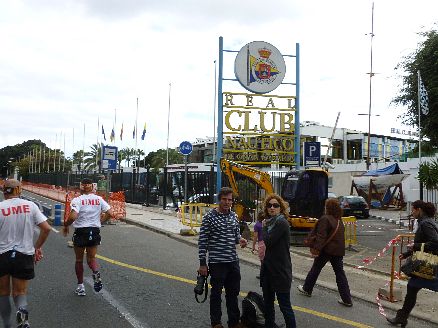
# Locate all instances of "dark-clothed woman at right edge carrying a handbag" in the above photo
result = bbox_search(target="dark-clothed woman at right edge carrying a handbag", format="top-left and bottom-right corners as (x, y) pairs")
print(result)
(386, 200), (438, 327)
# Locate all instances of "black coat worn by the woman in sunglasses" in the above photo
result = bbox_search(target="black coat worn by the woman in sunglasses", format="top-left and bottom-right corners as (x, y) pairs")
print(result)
(260, 216), (292, 293)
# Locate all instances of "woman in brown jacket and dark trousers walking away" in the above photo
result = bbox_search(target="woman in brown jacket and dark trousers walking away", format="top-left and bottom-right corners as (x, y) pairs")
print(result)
(297, 198), (353, 307)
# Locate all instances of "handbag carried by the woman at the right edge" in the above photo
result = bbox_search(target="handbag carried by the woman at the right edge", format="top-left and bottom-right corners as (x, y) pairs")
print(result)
(400, 243), (438, 280)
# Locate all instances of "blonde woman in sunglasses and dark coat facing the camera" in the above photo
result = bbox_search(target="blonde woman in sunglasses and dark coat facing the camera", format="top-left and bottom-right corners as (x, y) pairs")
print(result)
(260, 194), (296, 328)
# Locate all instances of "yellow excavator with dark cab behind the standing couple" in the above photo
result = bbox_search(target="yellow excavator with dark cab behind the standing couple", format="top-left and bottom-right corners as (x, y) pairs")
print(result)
(220, 158), (328, 232)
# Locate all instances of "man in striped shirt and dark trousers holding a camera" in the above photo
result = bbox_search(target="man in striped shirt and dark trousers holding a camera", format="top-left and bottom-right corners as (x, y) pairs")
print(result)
(198, 187), (247, 328)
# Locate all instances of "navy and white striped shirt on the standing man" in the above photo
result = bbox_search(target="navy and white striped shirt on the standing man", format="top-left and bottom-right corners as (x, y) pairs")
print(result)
(198, 209), (240, 265)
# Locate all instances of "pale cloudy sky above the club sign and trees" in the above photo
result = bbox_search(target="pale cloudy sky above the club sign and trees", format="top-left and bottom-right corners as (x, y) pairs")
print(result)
(0, 0), (438, 155)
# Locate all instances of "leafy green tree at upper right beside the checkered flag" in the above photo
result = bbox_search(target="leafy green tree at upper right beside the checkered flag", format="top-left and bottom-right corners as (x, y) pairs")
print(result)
(392, 26), (438, 148)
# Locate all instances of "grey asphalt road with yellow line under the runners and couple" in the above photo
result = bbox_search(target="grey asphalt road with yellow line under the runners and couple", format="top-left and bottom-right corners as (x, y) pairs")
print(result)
(0, 191), (432, 328)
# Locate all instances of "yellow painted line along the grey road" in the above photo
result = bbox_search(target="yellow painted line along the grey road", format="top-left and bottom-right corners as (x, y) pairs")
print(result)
(96, 255), (372, 328)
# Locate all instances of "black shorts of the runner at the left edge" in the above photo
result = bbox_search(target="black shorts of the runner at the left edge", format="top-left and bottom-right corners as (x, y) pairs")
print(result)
(0, 251), (35, 280)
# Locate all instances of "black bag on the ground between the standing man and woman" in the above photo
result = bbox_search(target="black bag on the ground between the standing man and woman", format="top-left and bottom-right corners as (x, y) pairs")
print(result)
(240, 292), (265, 328)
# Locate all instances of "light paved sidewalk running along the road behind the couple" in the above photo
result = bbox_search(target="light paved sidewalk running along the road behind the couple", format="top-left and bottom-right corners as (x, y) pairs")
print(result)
(120, 203), (438, 324)
